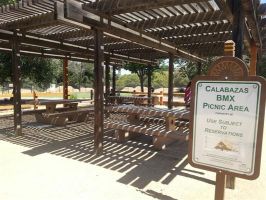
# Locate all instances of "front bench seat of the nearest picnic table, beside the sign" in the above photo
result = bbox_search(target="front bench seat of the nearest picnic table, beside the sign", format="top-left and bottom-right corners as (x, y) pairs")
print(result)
(104, 120), (189, 150)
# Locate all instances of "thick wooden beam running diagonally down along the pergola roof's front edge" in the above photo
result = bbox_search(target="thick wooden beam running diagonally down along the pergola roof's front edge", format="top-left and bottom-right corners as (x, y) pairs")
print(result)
(57, 1), (204, 61)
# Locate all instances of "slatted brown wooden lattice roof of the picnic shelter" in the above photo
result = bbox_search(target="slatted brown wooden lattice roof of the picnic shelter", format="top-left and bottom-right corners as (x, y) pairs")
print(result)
(0, 0), (266, 63)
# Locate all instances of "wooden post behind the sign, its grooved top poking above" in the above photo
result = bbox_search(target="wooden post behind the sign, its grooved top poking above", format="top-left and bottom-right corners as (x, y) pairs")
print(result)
(224, 40), (235, 189)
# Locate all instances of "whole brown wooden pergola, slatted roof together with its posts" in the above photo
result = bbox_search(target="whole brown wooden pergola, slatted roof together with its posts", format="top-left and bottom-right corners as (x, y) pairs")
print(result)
(0, 0), (265, 153)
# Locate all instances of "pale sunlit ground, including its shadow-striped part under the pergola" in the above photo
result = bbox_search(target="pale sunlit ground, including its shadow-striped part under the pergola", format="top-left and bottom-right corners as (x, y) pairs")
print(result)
(0, 111), (266, 200)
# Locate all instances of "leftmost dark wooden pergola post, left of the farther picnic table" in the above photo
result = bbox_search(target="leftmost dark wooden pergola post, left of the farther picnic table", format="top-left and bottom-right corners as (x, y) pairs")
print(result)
(11, 32), (23, 136)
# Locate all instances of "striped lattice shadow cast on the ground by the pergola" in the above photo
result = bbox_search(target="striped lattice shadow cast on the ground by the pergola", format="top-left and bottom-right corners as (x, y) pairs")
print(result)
(0, 113), (215, 200)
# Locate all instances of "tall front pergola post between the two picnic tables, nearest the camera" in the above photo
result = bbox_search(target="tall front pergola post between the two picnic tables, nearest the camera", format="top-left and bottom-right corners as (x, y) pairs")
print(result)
(94, 29), (104, 155)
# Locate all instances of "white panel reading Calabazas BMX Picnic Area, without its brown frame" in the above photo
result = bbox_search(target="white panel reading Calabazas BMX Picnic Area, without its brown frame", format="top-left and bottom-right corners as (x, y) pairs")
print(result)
(192, 80), (261, 175)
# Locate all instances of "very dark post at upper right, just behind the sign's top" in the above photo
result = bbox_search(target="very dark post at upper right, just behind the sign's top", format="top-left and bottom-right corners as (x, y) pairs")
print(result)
(228, 0), (245, 59)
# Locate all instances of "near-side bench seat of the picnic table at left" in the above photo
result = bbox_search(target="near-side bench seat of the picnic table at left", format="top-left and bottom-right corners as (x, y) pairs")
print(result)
(39, 108), (94, 126)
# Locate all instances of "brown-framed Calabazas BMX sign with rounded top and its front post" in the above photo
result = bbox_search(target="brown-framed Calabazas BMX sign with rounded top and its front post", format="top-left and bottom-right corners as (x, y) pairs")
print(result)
(189, 57), (265, 199)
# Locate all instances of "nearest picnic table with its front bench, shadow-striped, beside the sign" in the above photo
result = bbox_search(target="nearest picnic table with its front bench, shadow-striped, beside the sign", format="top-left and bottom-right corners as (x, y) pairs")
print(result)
(104, 105), (189, 150)
